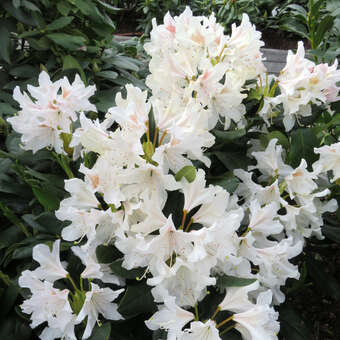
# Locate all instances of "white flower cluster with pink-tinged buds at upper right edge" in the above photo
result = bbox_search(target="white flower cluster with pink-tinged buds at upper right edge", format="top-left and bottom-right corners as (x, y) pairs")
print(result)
(260, 41), (340, 131)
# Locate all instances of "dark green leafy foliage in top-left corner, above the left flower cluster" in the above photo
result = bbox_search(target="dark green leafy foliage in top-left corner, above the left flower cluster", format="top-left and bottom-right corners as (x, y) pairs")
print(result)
(0, 0), (145, 116)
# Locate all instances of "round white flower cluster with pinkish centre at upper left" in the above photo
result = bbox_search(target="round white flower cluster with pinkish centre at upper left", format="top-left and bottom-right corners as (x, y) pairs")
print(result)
(8, 72), (97, 153)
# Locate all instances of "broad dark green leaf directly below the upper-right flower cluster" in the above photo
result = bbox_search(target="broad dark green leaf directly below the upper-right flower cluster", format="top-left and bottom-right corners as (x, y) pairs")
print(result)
(287, 128), (319, 169)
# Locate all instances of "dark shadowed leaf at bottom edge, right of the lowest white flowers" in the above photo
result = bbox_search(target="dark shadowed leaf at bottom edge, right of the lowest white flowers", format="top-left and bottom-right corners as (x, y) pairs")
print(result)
(279, 306), (312, 340)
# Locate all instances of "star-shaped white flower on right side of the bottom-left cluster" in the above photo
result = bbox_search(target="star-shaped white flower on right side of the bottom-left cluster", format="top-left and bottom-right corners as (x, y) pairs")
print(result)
(76, 283), (124, 339)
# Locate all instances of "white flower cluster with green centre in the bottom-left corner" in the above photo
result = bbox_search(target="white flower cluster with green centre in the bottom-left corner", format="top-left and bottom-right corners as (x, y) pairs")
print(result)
(19, 240), (123, 340)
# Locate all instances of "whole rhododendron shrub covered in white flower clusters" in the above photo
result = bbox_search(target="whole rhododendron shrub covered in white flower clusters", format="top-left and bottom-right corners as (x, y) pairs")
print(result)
(8, 8), (340, 340)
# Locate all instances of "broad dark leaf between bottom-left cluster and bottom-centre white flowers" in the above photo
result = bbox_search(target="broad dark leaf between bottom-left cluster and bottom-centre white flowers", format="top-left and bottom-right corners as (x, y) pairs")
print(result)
(118, 284), (157, 319)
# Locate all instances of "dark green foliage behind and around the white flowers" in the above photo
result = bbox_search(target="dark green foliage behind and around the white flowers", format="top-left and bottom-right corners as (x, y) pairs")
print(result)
(0, 0), (340, 340)
